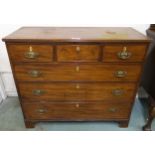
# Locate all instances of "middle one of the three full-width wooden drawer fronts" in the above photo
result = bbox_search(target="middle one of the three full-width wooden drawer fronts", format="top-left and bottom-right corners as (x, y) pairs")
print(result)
(19, 83), (136, 102)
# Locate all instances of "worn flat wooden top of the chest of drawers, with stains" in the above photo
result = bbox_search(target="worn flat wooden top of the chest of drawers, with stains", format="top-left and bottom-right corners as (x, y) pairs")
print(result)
(3, 27), (149, 42)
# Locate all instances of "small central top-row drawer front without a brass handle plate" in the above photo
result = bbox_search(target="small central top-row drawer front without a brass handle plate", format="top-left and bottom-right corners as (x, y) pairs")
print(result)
(57, 45), (101, 62)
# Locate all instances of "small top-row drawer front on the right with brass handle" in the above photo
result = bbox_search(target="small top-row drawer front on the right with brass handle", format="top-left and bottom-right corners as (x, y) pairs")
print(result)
(103, 44), (147, 62)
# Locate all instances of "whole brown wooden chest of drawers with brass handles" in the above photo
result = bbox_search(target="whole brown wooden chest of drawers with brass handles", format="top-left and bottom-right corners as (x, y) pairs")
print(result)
(3, 27), (149, 127)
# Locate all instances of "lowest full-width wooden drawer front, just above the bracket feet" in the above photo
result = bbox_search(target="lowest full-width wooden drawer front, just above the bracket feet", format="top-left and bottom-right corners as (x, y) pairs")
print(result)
(23, 102), (131, 121)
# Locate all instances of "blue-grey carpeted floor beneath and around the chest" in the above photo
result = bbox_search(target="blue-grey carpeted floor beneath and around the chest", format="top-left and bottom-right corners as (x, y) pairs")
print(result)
(0, 97), (155, 131)
